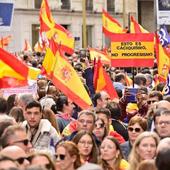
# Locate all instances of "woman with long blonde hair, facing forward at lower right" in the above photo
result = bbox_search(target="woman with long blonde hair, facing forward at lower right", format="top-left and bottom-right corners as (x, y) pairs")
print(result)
(128, 132), (159, 170)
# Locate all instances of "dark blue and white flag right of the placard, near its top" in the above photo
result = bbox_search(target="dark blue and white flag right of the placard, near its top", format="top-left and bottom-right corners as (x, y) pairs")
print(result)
(158, 25), (170, 47)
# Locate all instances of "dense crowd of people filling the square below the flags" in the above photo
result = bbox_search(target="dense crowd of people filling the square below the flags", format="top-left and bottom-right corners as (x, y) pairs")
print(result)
(0, 48), (170, 170)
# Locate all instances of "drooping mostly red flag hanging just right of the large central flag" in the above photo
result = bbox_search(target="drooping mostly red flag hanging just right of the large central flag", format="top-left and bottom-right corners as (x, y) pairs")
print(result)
(93, 59), (118, 99)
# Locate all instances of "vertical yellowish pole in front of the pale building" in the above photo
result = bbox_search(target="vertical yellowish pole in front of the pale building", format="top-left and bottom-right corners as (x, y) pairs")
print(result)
(82, 0), (87, 49)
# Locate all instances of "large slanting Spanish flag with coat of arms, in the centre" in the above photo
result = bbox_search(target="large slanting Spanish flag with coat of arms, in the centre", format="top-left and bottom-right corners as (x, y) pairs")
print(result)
(47, 51), (92, 109)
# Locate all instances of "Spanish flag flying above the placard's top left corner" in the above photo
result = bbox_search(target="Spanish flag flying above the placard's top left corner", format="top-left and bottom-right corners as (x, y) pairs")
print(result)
(102, 9), (125, 37)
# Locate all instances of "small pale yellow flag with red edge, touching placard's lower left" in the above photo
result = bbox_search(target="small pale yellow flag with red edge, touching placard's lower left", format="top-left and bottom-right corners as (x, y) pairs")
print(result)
(89, 48), (110, 64)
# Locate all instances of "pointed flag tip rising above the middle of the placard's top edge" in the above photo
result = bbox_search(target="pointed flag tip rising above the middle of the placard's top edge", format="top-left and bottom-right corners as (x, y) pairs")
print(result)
(130, 16), (149, 33)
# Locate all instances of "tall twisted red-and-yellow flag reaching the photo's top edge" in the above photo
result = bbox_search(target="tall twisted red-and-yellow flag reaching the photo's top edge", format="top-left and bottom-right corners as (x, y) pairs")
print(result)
(40, 0), (74, 54)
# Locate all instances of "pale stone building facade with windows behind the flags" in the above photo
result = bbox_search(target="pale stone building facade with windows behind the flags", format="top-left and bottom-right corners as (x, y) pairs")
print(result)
(0, 0), (142, 52)
